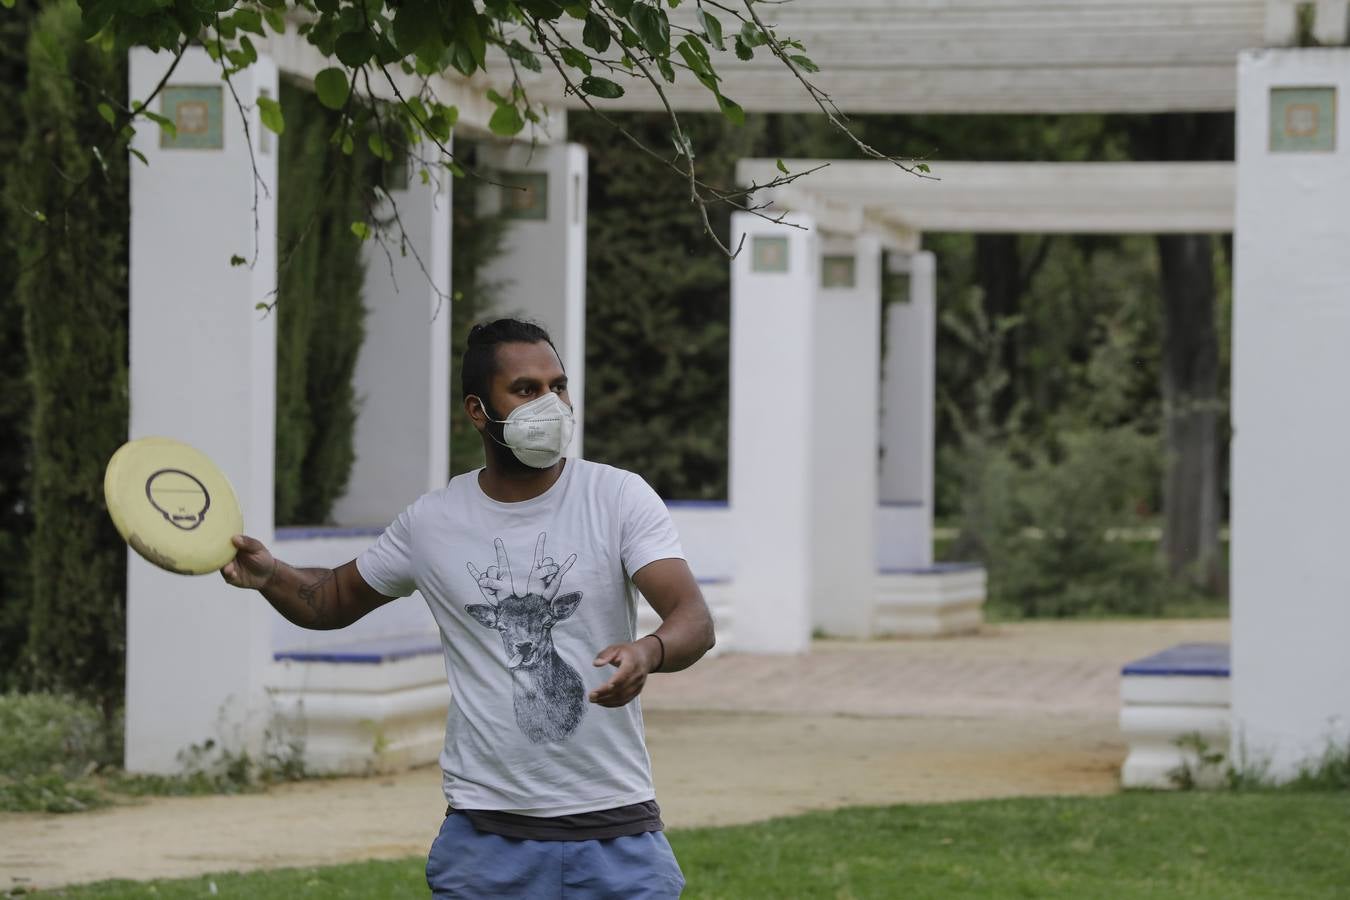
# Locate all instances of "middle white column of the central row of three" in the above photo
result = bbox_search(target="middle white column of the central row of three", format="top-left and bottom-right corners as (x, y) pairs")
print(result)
(801, 236), (882, 638)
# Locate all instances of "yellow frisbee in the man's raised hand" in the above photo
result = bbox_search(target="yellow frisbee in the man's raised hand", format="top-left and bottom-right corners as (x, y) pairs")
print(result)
(103, 437), (244, 575)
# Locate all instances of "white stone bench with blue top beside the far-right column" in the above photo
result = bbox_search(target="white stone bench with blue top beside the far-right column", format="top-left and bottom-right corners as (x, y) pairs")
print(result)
(1121, 644), (1230, 788)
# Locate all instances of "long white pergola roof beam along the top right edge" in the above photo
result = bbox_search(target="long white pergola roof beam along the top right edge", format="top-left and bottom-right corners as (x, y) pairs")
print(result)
(507, 0), (1345, 113)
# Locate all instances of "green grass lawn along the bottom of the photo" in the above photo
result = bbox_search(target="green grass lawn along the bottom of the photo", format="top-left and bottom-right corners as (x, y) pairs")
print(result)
(43, 791), (1350, 900)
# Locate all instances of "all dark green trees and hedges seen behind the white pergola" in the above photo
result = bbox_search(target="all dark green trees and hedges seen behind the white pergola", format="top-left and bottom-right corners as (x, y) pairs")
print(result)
(0, 0), (1233, 806)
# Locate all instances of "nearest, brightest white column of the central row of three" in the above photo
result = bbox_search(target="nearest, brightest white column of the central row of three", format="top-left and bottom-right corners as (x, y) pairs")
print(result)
(729, 213), (825, 653)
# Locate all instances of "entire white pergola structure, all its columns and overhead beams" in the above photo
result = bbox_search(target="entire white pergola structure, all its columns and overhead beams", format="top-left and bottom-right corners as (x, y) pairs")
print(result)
(127, 0), (1350, 772)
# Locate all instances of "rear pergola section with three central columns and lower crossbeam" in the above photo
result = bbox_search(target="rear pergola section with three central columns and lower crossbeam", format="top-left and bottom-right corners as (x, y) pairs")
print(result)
(730, 159), (1237, 652)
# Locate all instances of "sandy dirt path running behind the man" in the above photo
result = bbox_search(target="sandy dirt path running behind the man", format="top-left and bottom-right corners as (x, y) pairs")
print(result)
(0, 622), (1227, 891)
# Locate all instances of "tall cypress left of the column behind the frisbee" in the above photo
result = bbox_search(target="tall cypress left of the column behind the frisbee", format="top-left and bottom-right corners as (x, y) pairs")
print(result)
(11, 0), (128, 716)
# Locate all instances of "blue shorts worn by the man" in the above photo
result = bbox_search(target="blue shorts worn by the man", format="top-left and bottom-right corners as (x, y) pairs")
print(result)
(427, 814), (684, 900)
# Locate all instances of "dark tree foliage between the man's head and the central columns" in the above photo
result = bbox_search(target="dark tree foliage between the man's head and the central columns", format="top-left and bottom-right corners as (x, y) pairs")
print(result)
(571, 115), (771, 499)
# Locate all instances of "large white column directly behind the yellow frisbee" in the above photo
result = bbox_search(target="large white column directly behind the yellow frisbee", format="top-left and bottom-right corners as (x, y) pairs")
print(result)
(126, 49), (277, 772)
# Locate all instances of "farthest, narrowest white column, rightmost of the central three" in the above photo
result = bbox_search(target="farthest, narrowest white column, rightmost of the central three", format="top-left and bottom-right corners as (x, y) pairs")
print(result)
(878, 252), (937, 568)
